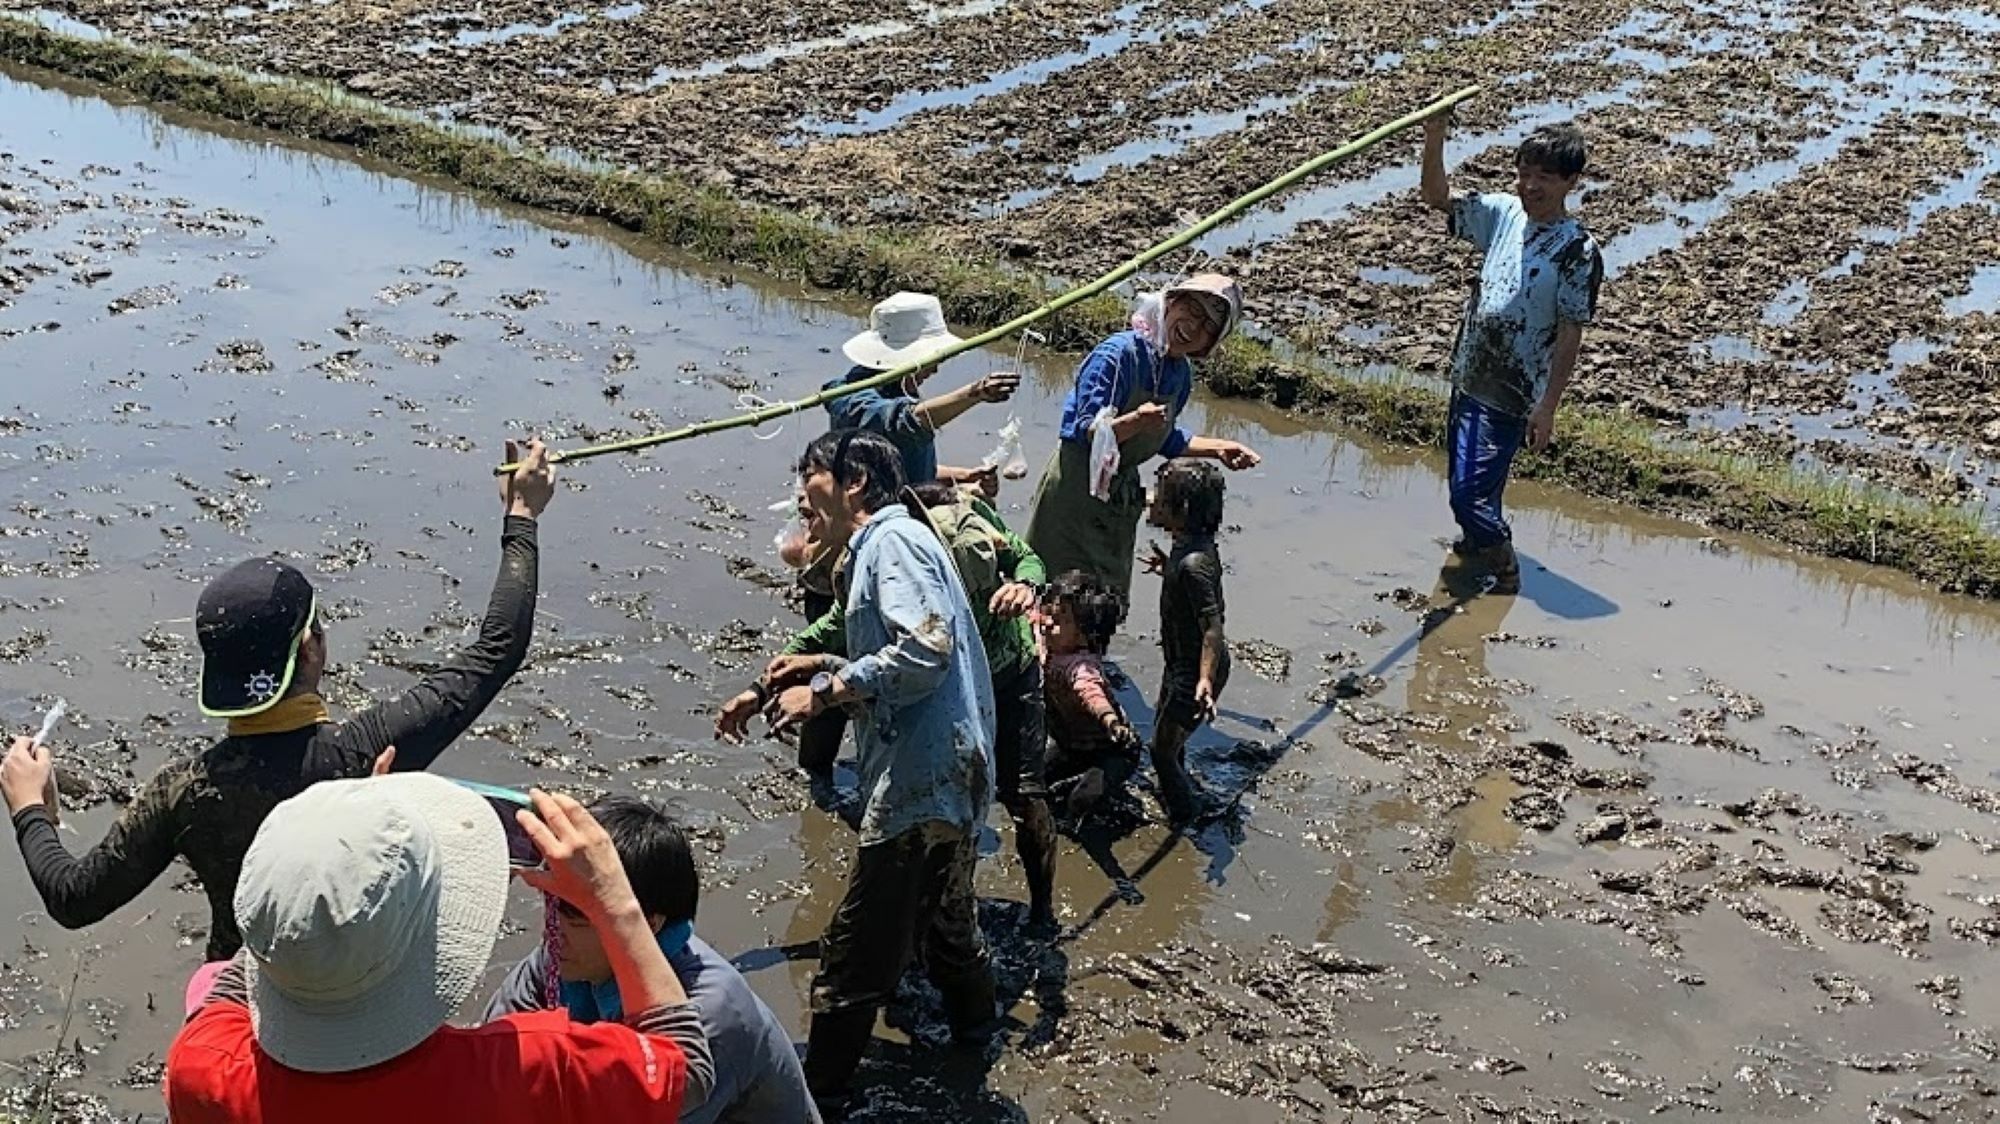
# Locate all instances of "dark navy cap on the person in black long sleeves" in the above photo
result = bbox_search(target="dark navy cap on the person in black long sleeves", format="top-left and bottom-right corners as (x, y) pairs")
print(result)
(194, 558), (318, 718)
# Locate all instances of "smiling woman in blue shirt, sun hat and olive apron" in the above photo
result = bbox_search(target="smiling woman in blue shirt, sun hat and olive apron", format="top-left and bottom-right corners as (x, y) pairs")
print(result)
(1028, 274), (1258, 602)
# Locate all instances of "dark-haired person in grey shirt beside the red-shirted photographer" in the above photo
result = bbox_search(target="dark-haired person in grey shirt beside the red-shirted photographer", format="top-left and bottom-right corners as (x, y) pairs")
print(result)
(486, 796), (820, 1124)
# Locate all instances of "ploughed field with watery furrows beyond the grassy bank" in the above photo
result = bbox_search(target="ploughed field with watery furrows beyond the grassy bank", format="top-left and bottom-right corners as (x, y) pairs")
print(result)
(12, 0), (2000, 500)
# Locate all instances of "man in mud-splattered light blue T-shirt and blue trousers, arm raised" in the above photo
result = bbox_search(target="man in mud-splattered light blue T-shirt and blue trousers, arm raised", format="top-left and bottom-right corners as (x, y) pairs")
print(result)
(1420, 114), (1604, 594)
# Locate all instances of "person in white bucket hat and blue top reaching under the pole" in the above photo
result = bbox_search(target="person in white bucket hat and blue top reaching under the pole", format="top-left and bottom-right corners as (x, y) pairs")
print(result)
(822, 292), (1020, 498)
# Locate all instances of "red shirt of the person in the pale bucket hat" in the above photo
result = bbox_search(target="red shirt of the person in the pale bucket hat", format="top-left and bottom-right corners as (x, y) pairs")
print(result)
(166, 1002), (688, 1124)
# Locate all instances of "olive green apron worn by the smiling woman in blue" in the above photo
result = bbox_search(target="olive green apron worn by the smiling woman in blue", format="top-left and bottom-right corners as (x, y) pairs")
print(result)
(1028, 370), (1180, 604)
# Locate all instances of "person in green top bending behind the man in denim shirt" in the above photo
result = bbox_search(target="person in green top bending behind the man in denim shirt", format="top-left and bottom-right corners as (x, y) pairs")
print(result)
(716, 482), (1056, 928)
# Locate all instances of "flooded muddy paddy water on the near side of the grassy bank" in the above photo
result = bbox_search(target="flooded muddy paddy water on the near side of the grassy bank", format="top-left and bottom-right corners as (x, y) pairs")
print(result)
(0, 65), (2000, 1122)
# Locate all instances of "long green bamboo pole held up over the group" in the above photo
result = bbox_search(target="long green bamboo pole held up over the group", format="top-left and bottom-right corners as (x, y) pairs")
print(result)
(494, 86), (1480, 476)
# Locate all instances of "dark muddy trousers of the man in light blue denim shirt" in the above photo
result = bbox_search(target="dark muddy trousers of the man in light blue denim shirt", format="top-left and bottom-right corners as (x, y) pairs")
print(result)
(806, 820), (994, 1102)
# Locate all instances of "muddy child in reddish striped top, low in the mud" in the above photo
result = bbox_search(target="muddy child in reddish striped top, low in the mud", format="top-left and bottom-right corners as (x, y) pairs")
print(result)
(1040, 570), (1144, 818)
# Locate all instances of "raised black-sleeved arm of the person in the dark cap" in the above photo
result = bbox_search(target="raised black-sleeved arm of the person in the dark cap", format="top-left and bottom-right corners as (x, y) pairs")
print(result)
(336, 516), (540, 772)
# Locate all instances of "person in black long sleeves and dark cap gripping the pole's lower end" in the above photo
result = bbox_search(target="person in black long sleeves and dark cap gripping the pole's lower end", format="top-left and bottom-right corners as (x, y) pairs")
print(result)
(0, 442), (556, 962)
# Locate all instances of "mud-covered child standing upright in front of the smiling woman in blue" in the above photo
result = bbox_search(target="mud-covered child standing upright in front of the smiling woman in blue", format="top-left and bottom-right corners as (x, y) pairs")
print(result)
(1146, 458), (1230, 824)
